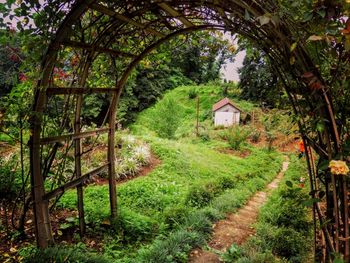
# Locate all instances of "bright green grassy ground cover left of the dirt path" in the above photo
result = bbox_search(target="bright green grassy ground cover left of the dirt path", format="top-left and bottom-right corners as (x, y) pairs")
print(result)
(59, 86), (283, 262)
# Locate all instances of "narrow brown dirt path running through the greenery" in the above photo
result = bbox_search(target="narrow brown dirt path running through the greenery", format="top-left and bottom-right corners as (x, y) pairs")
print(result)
(189, 161), (289, 263)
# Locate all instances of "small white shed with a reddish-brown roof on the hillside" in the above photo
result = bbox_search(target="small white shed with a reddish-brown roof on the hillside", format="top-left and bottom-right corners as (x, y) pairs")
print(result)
(213, 98), (241, 127)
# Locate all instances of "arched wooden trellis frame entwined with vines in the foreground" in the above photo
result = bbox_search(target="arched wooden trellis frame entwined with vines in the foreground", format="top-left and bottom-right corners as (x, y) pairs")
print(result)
(30, 0), (349, 260)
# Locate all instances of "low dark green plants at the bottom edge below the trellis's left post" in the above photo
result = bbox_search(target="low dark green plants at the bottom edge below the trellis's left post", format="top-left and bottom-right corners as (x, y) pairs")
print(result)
(24, 246), (109, 263)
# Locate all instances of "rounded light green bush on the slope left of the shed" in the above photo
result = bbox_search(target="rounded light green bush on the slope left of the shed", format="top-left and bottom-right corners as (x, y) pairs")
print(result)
(151, 98), (182, 139)
